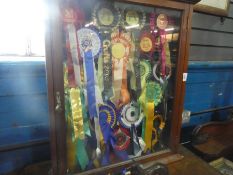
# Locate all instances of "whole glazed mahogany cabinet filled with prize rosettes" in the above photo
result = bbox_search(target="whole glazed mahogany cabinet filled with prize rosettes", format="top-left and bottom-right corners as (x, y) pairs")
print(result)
(46, 0), (197, 175)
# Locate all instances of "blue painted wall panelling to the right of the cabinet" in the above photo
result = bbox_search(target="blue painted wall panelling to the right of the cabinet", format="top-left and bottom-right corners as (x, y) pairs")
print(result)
(182, 61), (233, 142)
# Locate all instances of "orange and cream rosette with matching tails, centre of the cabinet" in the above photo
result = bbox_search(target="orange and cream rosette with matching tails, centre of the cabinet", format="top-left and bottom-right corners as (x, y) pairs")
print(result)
(111, 31), (131, 106)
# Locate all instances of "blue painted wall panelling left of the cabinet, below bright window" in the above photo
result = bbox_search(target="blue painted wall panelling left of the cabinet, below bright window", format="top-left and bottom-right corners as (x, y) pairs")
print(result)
(0, 61), (50, 174)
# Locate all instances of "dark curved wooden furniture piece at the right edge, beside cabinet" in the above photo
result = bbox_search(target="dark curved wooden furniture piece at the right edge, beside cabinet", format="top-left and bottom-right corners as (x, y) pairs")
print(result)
(192, 121), (233, 161)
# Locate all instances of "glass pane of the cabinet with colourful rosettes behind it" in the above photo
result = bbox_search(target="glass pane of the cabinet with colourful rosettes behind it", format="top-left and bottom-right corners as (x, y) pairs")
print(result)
(62, 0), (181, 173)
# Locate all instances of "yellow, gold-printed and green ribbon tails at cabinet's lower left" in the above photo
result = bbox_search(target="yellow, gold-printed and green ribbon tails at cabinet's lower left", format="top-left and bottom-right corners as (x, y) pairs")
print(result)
(64, 66), (89, 170)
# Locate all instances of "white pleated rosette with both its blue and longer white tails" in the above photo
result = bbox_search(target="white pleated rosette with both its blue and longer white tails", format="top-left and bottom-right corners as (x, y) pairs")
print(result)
(77, 28), (101, 157)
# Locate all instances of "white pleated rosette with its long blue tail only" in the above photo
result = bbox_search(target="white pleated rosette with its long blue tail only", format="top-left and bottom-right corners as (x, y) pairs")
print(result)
(77, 28), (101, 118)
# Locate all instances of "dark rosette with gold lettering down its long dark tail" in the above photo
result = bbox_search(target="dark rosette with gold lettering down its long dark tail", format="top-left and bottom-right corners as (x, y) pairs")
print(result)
(92, 1), (121, 102)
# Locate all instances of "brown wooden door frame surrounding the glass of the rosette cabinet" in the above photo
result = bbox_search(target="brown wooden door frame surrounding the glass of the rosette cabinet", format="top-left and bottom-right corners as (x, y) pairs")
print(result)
(46, 0), (196, 175)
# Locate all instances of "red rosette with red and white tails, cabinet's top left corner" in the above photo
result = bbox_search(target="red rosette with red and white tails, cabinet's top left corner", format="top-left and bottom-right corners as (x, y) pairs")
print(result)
(63, 8), (90, 135)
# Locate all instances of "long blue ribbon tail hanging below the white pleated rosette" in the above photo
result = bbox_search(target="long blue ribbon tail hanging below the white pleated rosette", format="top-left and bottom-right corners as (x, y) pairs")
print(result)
(84, 50), (97, 119)
